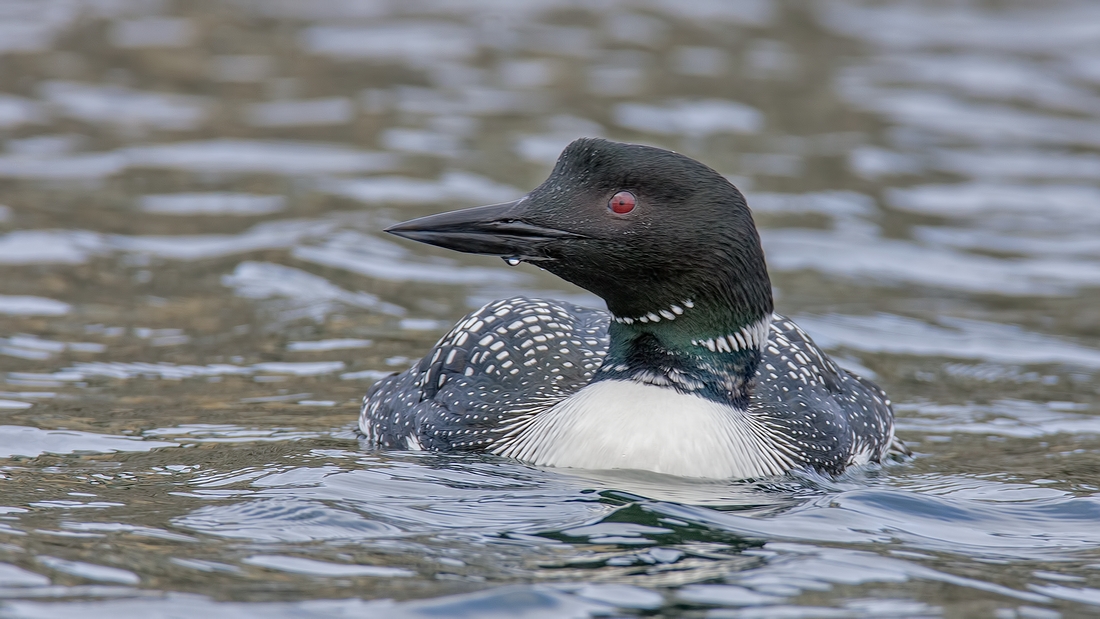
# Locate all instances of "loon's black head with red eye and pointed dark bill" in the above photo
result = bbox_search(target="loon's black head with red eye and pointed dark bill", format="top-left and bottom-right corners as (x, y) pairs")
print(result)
(386, 139), (772, 345)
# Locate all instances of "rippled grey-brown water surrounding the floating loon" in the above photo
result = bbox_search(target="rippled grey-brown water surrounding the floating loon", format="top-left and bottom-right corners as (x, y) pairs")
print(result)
(0, 0), (1100, 619)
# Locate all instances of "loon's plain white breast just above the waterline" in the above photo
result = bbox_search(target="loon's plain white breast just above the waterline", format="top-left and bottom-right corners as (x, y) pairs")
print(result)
(493, 380), (792, 478)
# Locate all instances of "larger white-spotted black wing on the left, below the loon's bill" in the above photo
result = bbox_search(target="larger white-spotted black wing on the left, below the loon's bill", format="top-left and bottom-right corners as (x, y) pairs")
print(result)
(359, 297), (609, 450)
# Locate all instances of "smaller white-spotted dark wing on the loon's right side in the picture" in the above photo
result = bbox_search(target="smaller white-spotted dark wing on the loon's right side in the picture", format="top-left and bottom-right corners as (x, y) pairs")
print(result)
(749, 314), (906, 473)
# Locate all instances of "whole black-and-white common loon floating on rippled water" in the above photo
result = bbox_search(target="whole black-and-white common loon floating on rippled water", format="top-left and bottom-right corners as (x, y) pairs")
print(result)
(359, 139), (908, 478)
